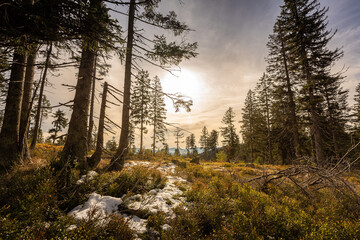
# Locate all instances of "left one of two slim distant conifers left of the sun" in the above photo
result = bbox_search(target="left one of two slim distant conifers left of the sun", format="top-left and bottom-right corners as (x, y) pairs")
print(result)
(131, 71), (151, 154)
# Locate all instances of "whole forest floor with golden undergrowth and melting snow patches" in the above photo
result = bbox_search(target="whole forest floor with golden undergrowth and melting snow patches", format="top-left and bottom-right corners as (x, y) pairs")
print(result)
(0, 145), (360, 239)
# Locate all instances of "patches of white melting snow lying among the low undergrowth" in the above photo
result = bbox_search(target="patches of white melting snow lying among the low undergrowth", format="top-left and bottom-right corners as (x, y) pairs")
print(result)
(69, 161), (187, 233)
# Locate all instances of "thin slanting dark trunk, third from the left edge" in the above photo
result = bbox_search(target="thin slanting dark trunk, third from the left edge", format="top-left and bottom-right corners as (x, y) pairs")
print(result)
(30, 42), (52, 149)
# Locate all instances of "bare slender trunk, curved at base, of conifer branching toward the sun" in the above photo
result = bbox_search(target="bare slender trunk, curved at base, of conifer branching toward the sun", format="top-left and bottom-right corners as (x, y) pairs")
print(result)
(109, 0), (136, 170)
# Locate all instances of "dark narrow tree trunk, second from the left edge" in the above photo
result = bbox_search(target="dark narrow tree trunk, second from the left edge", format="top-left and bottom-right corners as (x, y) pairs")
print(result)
(19, 45), (38, 161)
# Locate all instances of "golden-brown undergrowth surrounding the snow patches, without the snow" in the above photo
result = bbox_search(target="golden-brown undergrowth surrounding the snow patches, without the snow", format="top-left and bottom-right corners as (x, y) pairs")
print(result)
(0, 145), (360, 240)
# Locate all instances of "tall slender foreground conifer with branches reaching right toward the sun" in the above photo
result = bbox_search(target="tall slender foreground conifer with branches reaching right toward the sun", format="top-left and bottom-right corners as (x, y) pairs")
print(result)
(110, 0), (197, 170)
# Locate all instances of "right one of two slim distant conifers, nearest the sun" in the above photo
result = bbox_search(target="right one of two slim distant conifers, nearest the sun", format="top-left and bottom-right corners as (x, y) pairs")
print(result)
(149, 76), (166, 154)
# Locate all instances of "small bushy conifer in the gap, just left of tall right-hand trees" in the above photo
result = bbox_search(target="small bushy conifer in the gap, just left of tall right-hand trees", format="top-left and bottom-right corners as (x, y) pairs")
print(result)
(221, 107), (239, 161)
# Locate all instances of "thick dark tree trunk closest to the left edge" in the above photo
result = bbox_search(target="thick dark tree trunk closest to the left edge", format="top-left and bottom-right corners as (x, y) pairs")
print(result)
(0, 49), (26, 172)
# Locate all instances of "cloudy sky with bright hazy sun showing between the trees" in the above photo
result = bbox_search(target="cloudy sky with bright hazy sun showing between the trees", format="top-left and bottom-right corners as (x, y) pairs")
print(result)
(44, 0), (360, 148)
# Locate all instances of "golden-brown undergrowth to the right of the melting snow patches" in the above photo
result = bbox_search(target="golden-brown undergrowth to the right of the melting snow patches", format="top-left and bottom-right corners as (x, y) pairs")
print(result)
(152, 166), (360, 240)
